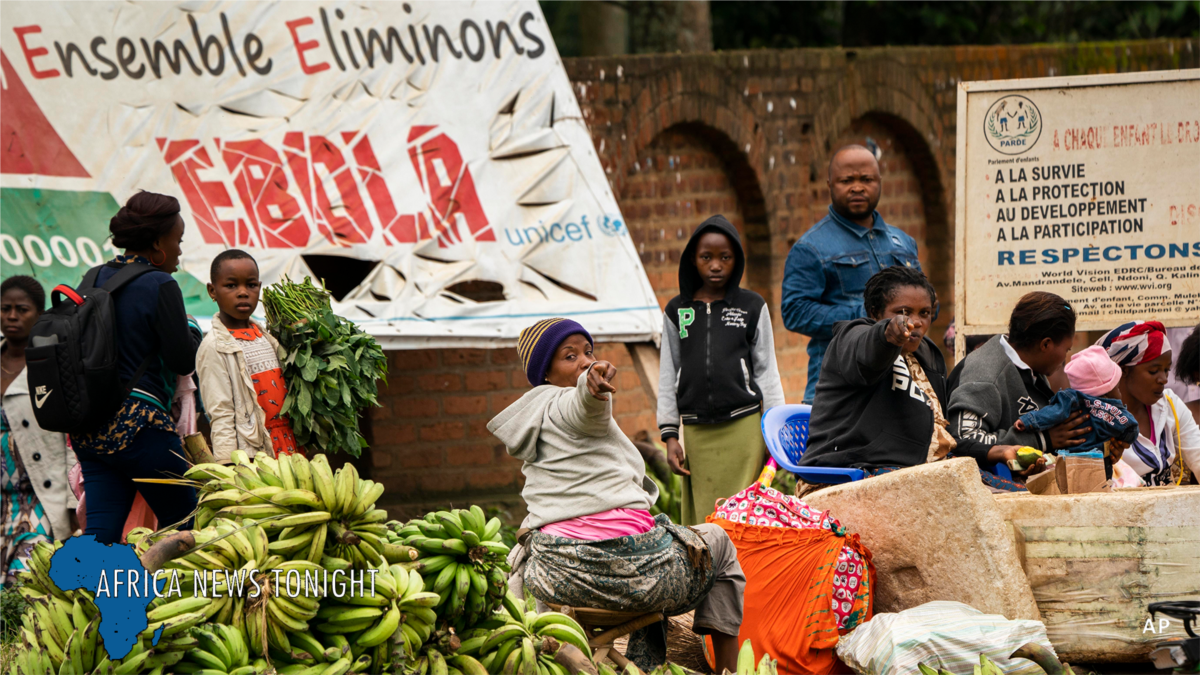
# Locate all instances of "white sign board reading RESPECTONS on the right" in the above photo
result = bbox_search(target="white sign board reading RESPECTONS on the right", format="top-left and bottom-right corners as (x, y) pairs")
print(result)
(955, 70), (1200, 353)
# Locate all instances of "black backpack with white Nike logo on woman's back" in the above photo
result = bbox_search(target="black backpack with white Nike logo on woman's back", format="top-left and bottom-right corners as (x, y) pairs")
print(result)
(25, 263), (155, 434)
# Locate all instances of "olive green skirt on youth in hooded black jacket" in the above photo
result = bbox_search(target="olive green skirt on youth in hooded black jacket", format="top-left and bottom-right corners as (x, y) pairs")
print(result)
(682, 412), (767, 525)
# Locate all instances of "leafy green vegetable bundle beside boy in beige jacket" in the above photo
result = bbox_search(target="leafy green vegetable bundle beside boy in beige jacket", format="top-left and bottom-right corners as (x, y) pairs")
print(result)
(263, 276), (388, 456)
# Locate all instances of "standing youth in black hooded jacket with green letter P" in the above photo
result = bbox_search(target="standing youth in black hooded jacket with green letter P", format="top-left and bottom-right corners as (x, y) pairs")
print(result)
(658, 215), (784, 525)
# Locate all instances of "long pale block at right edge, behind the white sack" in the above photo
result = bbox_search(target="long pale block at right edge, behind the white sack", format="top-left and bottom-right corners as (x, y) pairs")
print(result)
(988, 486), (1200, 663)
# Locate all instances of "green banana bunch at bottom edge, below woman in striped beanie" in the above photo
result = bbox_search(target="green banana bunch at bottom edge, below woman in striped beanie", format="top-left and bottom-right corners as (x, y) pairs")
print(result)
(470, 592), (592, 675)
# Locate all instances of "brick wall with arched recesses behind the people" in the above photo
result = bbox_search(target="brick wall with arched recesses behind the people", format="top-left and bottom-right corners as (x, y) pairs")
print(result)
(371, 40), (1200, 508)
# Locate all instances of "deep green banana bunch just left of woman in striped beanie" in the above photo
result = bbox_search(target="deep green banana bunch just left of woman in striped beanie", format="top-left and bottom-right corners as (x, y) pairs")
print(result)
(389, 506), (509, 631)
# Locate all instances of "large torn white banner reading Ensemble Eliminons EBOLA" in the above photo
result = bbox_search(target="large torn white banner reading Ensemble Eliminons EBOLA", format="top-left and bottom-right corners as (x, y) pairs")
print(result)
(0, 0), (661, 347)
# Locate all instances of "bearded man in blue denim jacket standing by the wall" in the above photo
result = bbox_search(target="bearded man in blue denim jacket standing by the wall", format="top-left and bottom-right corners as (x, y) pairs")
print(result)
(782, 145), (920, 404)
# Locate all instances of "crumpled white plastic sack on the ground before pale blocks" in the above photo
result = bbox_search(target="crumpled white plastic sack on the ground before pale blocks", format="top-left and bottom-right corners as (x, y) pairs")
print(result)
(838, 601), (1054, 675)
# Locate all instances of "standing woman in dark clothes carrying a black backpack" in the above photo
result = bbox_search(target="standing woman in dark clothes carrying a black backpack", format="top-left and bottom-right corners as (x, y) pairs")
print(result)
(71, 192), (203, 544)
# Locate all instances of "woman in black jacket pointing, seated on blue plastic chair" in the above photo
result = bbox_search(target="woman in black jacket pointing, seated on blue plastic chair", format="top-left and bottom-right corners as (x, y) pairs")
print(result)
(798, 267), (1024, 494)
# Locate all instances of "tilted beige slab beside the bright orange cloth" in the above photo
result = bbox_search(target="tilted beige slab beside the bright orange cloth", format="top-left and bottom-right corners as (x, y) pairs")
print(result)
(805, 458), (1040, 620)
